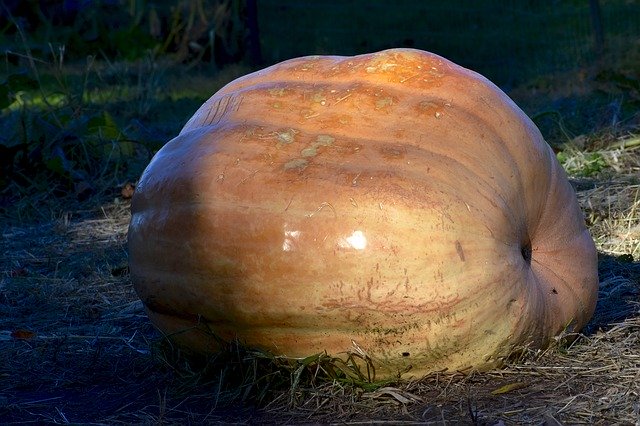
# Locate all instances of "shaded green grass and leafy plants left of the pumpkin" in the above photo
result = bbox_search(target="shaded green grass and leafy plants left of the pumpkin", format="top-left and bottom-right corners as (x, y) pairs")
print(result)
(0, 44), (248, 219)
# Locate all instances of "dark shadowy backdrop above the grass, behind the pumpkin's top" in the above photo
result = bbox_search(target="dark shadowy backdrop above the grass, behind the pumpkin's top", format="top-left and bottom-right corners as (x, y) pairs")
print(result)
(0, 0), (640, 88)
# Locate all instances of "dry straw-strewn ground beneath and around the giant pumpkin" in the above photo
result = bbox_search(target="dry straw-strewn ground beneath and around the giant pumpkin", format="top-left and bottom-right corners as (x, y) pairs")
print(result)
(0, 142), (640, 425)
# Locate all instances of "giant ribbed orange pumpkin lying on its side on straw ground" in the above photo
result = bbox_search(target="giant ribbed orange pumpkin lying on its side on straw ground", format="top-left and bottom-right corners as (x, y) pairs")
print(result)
(128, 49), (598, 378)
